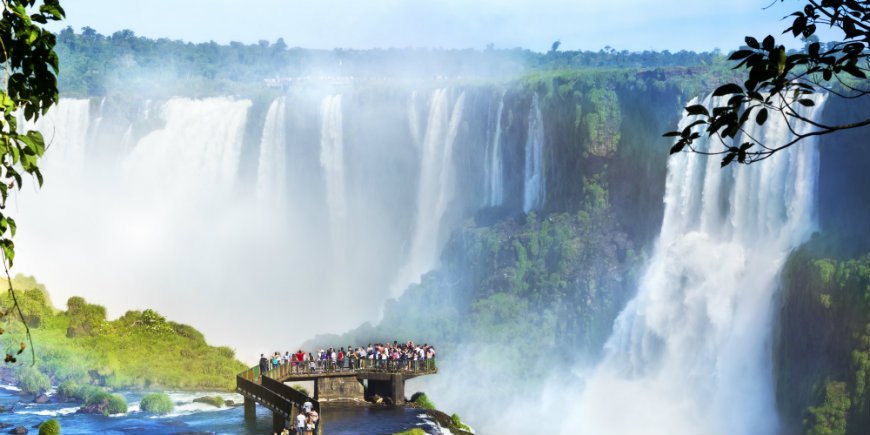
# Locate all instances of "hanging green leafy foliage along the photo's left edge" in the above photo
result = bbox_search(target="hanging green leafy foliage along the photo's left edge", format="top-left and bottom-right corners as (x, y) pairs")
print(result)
(0, 0), (64, 362)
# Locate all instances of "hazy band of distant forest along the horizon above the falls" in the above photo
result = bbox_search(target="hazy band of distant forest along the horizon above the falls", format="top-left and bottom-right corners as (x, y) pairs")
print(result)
(51, 27), (724, 98)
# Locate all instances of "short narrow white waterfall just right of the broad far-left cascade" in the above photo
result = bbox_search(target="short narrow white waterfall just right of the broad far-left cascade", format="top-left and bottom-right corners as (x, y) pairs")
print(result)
(257, 97), (287, 204)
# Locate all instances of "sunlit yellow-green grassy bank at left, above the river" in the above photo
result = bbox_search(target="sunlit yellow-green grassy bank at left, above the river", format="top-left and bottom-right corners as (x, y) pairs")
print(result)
(0, 276), (245, 397)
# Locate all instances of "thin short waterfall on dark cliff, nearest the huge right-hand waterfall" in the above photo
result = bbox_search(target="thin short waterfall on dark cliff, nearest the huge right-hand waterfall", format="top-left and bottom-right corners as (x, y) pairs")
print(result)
(523, 94), (545, 213)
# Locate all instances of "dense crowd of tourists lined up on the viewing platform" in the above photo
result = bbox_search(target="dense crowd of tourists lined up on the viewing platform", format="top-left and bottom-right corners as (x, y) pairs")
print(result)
(260, 341), (435, 373)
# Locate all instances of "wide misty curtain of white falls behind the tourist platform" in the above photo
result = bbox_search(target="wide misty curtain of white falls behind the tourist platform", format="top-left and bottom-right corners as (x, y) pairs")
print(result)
(16, 87), (544, 359)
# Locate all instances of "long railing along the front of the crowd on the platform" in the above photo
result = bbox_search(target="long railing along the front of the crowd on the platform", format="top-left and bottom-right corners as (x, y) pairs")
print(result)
(258, 358), (438, 379)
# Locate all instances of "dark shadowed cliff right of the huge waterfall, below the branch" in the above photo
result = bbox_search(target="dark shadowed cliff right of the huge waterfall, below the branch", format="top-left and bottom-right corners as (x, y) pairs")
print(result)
(774, 99), (870, 434)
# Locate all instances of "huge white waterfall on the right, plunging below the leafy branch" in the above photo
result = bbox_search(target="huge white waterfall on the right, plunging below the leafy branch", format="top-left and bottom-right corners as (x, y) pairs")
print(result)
(565, 96), (824, 435)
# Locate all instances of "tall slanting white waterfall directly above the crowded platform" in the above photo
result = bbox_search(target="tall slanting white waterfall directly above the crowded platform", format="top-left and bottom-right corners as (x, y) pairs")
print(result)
(391, 89), (465, 296)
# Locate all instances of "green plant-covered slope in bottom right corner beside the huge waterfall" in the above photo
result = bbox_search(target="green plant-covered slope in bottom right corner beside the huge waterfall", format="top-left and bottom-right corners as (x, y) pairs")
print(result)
(775, 245), (870, 435)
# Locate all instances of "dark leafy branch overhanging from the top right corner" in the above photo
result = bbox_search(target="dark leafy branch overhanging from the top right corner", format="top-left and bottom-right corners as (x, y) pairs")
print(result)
(665, 0), (870, 167)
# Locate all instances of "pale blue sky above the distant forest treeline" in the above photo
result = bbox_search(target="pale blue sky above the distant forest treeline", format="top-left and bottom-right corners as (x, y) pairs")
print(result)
(52, 0), (801, 51)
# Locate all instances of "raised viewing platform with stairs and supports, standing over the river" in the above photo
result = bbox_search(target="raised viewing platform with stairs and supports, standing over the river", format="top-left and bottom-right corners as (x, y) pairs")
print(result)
(236, 359), (438, 433)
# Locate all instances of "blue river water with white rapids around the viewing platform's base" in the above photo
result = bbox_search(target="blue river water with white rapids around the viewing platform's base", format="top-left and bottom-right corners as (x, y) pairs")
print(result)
(0, 385), (448, 435)
